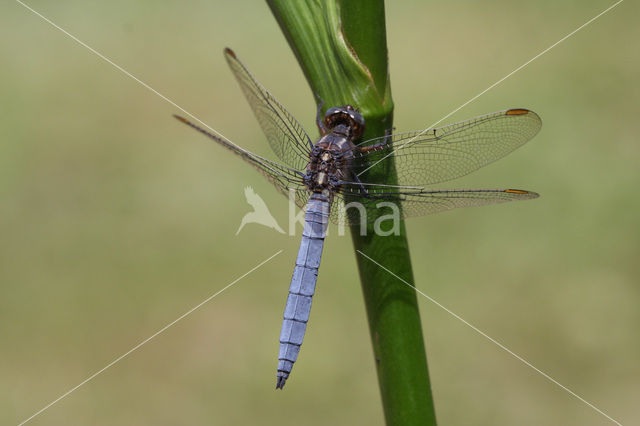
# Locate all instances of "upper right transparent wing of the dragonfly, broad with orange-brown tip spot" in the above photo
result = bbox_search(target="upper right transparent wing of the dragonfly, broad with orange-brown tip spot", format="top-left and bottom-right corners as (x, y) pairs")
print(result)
(353, 109), (542, 186)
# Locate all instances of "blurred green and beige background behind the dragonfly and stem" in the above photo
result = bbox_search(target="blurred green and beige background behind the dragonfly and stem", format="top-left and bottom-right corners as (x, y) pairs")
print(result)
(0, 0), (640, 425)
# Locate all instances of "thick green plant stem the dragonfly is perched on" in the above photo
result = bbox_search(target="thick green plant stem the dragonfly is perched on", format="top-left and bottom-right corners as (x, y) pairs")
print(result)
(267, 0), (436, 426)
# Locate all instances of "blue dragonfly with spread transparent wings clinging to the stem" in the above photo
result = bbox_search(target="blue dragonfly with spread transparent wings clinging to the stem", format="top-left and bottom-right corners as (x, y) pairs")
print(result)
(175, 48), (542, 389)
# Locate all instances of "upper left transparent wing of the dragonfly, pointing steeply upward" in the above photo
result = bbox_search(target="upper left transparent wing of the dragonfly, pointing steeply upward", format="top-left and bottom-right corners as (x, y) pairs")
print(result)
(224, 48), (313, 170)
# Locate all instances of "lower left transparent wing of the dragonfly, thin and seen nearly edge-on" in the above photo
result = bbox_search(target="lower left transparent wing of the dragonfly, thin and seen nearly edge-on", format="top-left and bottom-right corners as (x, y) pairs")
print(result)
(174, 115), (308, 200)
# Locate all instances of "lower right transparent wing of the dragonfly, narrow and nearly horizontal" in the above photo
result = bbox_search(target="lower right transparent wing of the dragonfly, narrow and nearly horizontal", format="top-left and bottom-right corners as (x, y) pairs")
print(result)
(332, 183), (538, 225)
